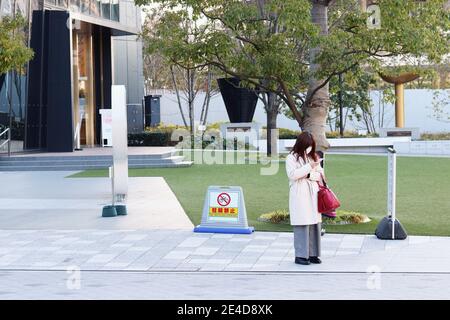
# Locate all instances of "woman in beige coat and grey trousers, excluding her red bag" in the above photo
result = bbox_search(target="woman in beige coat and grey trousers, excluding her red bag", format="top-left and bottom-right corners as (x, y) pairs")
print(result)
(286, 132), (323, 265)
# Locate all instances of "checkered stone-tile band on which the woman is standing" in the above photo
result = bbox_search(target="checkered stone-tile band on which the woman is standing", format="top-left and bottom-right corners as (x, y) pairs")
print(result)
(0, 229), (450, 273)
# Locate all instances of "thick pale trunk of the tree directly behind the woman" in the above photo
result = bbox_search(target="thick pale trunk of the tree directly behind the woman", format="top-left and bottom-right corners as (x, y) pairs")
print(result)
(302, 1), (331, 151)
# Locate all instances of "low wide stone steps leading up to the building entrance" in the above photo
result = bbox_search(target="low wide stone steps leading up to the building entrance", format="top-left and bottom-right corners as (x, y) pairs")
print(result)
(0, 151), (192, 171)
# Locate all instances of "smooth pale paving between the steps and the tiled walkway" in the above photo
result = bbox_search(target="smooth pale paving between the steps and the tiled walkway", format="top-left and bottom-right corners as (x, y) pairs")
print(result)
(0, 171), (193, 230)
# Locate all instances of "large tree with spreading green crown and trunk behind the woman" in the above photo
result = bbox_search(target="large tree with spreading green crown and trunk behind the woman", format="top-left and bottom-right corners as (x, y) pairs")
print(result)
(136, 0), (450, 149)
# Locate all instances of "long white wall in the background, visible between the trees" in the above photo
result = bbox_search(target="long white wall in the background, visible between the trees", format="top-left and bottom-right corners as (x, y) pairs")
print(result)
(157, 89), (450, 132)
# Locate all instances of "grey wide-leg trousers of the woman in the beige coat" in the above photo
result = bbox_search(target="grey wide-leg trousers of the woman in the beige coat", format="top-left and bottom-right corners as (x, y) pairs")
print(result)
(294, 223), (322, 259)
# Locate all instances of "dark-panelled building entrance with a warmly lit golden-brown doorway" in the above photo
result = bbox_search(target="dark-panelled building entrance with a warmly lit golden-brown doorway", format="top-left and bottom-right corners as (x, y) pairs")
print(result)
(25, 11), (132, 152)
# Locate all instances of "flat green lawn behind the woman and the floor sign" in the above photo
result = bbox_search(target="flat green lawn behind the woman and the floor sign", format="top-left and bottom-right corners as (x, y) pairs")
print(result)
(70, 155), (450, 236)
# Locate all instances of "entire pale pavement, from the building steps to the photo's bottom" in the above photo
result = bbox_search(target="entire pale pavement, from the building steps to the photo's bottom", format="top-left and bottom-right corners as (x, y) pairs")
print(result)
(0, 172), (450, 299)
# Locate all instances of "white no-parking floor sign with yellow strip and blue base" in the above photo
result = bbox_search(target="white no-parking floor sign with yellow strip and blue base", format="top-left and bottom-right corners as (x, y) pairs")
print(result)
(194, 186), (254, 234)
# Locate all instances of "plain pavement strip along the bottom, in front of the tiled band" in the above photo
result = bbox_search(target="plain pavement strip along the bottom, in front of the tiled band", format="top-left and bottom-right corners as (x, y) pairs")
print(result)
(0, 270), (450, 305)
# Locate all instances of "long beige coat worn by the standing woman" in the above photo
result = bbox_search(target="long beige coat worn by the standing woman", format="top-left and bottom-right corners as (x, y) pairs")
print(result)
(286, 153), (323, 226)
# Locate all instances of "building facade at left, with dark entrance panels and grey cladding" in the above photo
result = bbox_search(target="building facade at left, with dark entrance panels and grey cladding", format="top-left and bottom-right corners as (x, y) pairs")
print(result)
(0, 0), (144, 152)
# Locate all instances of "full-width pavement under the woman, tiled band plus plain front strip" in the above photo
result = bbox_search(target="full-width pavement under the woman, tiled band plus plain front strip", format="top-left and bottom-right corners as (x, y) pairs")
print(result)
(0, 230), (450, 299)
